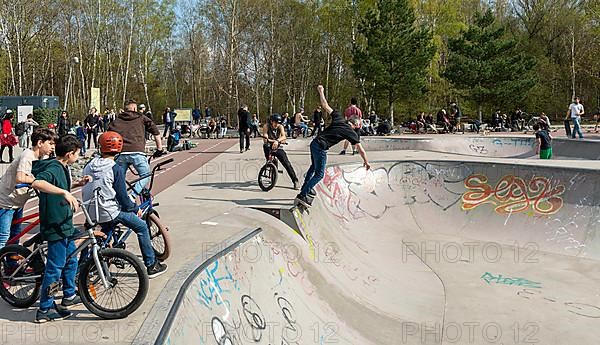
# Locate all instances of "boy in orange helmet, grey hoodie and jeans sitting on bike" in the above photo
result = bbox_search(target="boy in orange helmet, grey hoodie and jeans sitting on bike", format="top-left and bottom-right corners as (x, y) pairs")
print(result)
(82, 131), (167, 278)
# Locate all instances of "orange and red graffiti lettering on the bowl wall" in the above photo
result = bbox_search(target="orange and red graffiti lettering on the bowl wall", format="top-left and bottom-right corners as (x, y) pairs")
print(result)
(462, 174), (565, 215)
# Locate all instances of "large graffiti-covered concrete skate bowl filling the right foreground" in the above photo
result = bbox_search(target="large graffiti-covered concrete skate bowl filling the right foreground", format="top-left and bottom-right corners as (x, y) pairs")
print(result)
(140, 161), (600, 345)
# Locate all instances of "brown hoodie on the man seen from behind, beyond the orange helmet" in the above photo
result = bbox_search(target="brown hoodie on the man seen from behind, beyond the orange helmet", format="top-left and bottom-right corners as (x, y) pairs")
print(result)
(108, 111), (160, 153)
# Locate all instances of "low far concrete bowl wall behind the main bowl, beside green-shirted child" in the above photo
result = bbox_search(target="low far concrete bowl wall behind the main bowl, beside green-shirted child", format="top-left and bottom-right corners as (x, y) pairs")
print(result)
(363, 135), (600, 160)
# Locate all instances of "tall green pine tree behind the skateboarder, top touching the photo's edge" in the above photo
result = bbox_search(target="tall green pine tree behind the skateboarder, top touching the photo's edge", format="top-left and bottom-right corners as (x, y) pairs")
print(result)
(352, 0), (435, 124)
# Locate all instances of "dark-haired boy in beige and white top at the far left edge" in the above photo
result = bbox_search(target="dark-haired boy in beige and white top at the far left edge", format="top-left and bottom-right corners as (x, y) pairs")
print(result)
(0, 128), (58, 248)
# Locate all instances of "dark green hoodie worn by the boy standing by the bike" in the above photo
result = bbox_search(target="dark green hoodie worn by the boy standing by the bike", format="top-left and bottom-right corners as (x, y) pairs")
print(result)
(31, 159), (77, 241)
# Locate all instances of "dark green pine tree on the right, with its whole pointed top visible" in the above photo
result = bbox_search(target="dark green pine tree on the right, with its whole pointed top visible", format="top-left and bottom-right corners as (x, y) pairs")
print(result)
(444, 10), (536, 121)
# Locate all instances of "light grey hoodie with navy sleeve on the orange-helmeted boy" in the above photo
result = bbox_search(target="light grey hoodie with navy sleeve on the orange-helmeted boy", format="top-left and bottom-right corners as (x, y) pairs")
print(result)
(81, 158), (137, 223)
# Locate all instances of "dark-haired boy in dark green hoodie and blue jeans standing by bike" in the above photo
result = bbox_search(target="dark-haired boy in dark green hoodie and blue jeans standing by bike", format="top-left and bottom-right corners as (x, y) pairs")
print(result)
(31, 134), (89, 323)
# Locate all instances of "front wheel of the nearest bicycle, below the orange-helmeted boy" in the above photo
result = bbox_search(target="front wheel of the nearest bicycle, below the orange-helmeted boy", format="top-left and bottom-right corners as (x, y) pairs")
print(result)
(77, 248), (149, 319)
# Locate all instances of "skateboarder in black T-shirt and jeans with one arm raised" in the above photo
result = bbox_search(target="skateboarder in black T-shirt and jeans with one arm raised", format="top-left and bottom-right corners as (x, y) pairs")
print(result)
(295, 85), (371, 207)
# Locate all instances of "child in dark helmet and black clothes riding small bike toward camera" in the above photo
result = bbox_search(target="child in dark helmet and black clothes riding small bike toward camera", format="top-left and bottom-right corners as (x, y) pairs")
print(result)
(263, 114), (298, 189)
